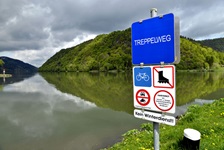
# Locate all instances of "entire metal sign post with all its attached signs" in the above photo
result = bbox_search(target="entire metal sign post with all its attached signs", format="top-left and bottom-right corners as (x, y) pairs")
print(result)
(131, 8), (180, 150)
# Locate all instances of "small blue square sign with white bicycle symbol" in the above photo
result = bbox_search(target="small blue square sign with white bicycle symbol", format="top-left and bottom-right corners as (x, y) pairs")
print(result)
(133, 67), (152, 87)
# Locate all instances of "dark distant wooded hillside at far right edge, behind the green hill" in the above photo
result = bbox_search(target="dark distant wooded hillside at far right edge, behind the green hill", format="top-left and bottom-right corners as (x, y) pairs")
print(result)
(198, 38), (224, 52)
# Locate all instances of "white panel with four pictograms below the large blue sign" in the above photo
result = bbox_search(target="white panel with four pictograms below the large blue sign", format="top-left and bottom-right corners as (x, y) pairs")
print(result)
(133, 65), (176, 114)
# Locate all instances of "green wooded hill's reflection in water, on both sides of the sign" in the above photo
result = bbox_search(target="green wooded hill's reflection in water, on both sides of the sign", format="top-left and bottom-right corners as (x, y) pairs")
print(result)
(41, 72), (224, 114)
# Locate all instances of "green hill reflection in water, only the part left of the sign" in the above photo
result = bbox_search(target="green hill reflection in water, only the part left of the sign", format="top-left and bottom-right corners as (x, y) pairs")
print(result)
(41, 73), (134, 114)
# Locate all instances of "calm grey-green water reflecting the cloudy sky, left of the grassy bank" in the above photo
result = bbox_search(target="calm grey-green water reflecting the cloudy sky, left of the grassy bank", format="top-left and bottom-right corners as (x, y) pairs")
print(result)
(0, 75), (143, 150)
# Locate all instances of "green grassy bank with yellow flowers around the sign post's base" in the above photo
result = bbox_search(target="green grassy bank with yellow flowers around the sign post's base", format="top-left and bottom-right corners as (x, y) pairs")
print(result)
(104, 98), (224, 150)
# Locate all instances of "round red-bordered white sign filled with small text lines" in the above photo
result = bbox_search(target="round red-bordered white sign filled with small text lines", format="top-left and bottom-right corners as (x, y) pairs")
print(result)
(154, 90), (174, 111)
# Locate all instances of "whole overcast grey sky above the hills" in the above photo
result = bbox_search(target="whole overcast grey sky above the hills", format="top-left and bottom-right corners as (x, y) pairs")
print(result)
(0, 0), (224, 67)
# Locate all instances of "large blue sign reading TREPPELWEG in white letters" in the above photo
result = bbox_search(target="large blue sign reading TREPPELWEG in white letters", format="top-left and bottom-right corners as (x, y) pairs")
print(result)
(131, 13), (175, 65)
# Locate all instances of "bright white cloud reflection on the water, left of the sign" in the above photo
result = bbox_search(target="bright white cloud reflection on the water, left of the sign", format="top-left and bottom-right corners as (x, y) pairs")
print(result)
(3, 75), (96, 111)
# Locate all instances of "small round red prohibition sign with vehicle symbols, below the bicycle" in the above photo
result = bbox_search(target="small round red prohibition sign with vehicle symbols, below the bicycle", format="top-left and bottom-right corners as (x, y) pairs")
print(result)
(135, 89), (150, 106)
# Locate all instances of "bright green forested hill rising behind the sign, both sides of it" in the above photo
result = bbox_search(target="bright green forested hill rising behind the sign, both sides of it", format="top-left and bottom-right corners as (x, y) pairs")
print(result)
(39, 28), (224, 71)
